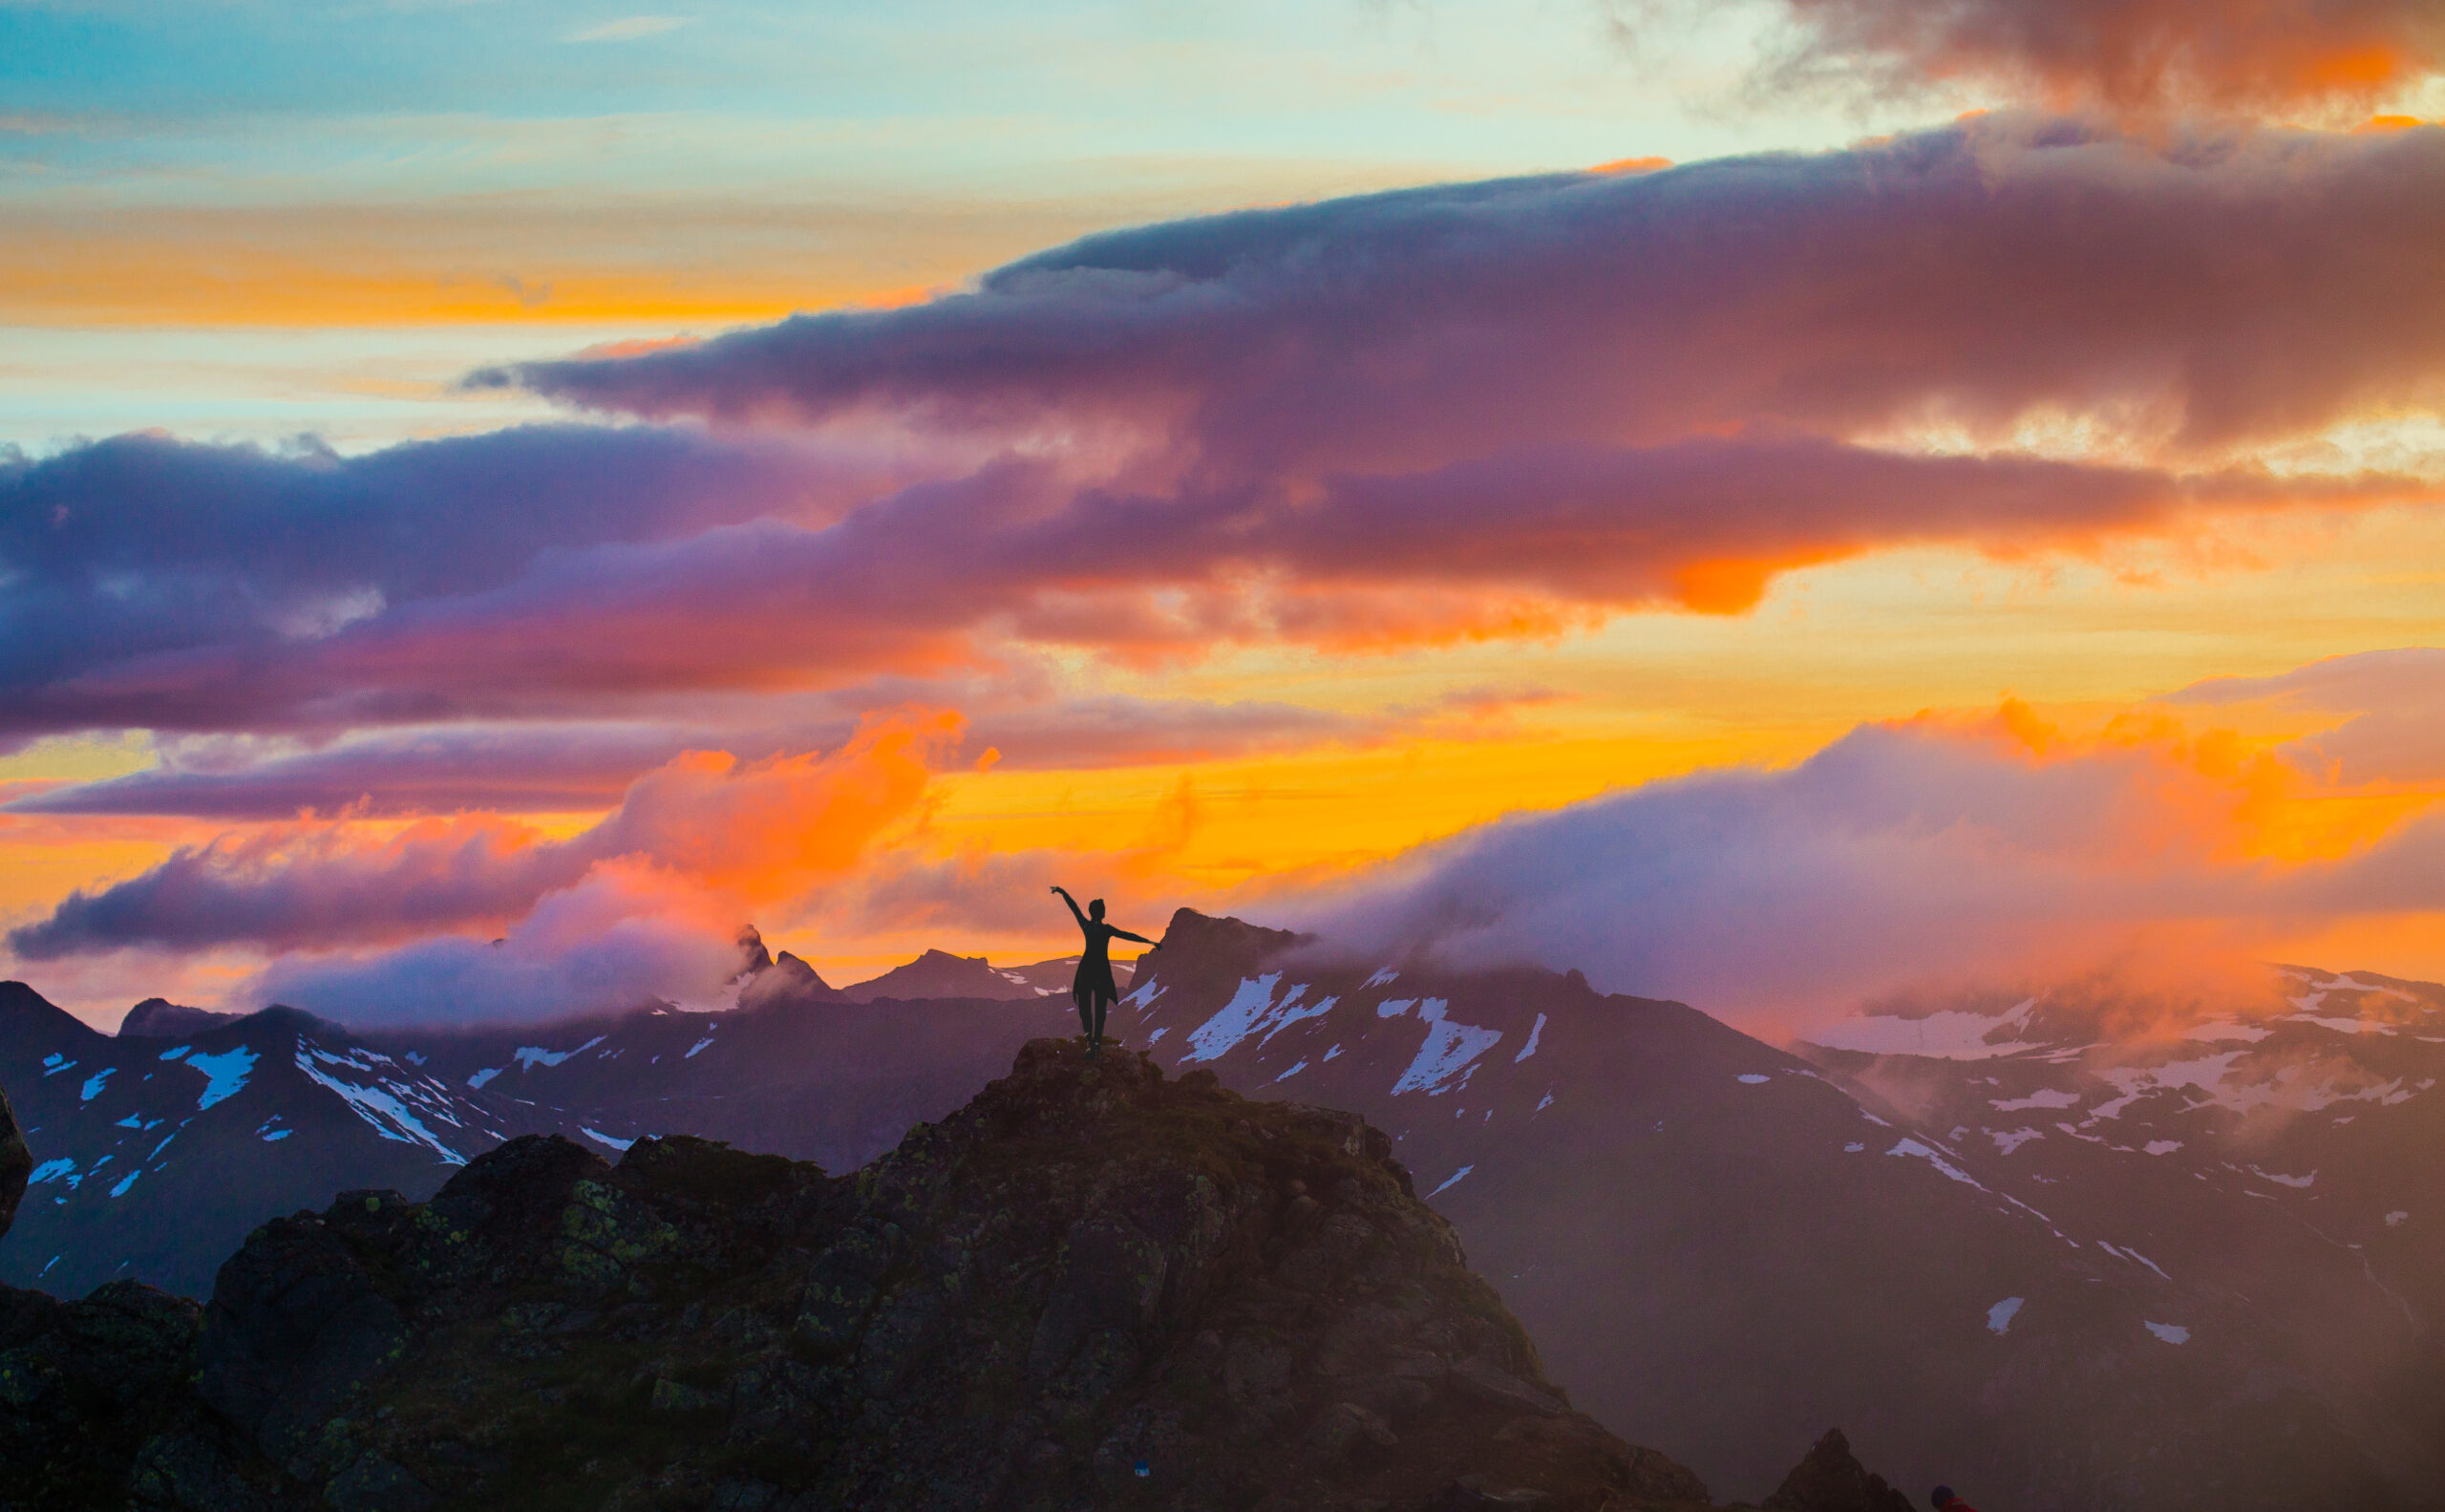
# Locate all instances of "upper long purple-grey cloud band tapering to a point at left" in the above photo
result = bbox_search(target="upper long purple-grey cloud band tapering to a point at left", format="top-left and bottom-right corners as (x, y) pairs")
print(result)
(484, 117), (2445, 452)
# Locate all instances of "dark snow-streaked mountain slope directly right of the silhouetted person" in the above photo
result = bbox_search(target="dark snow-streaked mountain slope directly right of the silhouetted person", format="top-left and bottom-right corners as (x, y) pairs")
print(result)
(1117, 915), (2445, 1512)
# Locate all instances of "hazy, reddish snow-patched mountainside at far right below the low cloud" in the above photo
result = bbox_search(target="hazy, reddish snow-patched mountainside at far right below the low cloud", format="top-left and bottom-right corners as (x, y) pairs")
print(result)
(1802, 967), (2445, 1487)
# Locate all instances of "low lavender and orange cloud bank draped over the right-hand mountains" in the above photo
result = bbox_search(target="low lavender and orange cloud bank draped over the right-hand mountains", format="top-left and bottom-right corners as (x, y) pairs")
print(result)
(1269, 650), (2445, 1020)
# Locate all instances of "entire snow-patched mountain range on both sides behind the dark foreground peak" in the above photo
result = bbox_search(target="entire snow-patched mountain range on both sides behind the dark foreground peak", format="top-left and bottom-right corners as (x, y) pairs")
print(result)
(0, 910), (2445, 1512)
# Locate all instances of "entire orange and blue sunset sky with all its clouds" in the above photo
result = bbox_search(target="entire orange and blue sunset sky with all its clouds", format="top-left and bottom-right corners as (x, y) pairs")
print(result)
(0, 0), (2445, 1028)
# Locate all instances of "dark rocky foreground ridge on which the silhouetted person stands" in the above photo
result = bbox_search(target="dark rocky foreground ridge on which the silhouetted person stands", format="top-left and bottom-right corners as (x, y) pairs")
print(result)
(0, 1040), (1904, 1512)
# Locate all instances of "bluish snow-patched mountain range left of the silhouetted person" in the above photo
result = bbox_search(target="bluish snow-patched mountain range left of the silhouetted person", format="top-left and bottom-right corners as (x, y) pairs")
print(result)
(0, 957), (1075, 1297)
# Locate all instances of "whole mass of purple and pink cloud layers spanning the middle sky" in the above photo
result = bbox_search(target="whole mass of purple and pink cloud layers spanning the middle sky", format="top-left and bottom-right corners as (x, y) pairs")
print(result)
(0, 117), (2445, 815)
